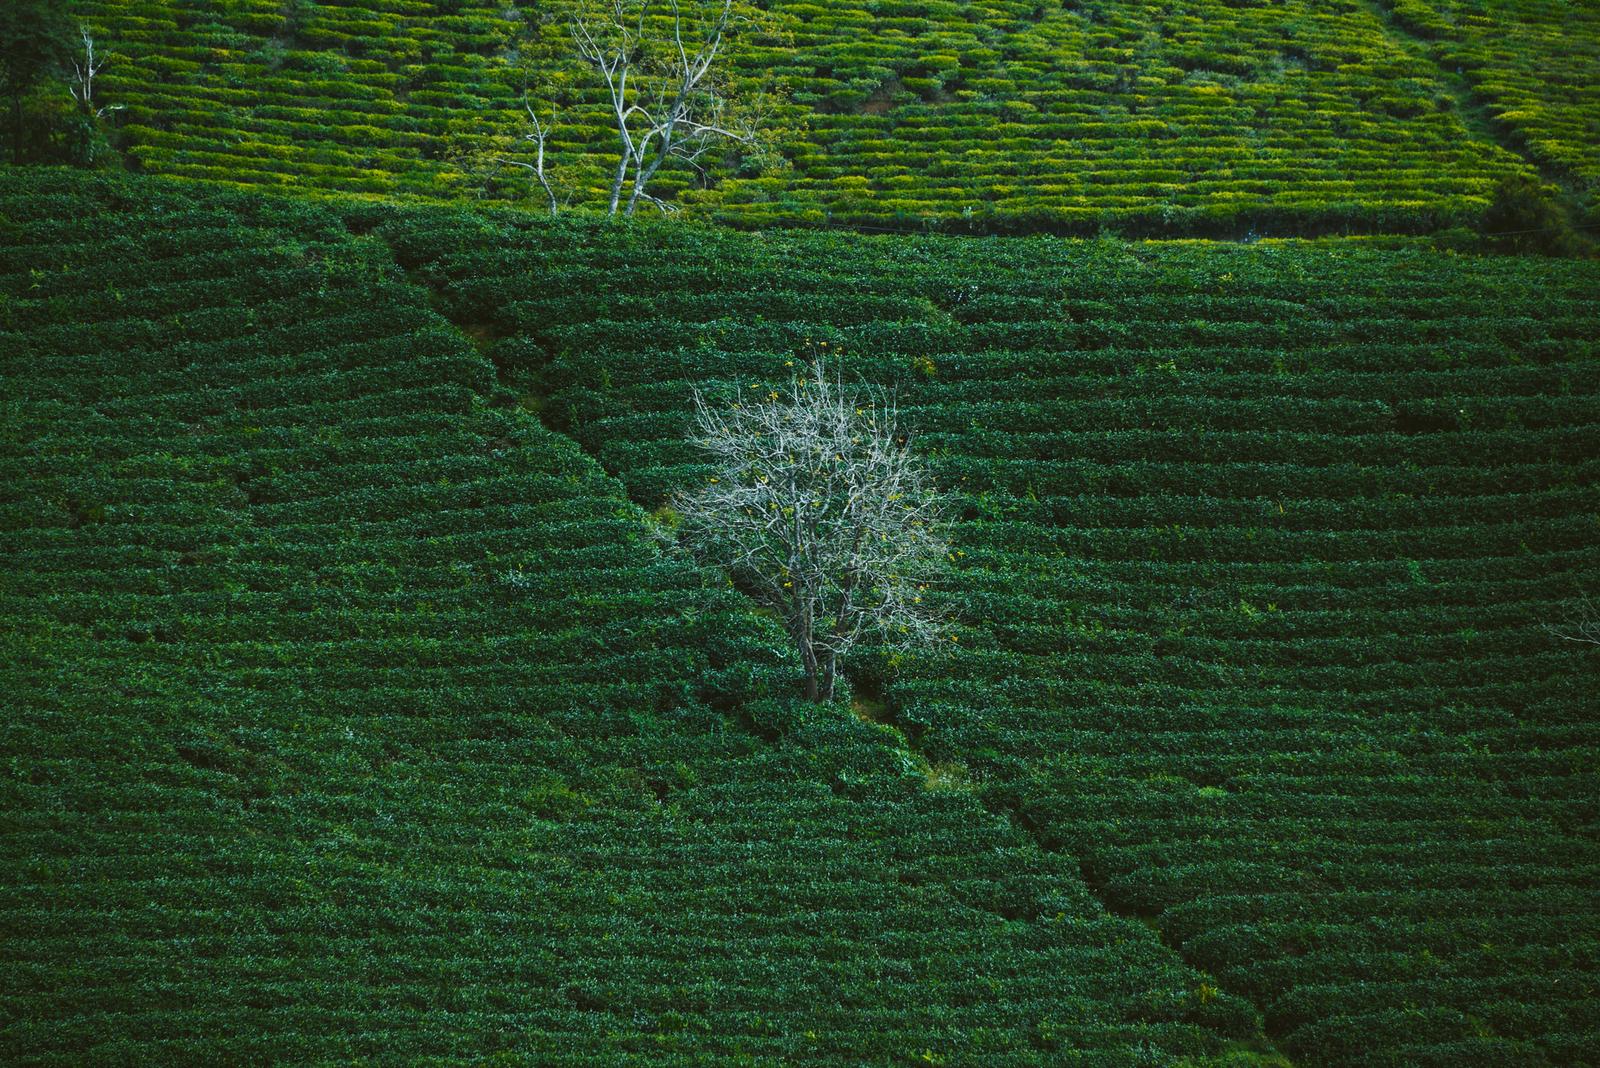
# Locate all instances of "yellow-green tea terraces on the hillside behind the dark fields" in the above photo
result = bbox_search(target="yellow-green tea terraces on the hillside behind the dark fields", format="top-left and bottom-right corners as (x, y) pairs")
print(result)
(75, 0), (1600, 235)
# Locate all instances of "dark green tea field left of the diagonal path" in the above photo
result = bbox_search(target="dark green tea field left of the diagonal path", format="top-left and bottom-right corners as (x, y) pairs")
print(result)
(0, 171), (1272, 1066)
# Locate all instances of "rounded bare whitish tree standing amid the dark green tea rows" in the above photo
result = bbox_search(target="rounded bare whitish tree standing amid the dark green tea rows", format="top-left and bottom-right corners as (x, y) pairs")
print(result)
(672, 366), (949, 700)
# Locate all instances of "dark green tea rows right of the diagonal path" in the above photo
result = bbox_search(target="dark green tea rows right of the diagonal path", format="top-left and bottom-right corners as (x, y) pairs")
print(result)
(390, 204), (1600, 1066)
